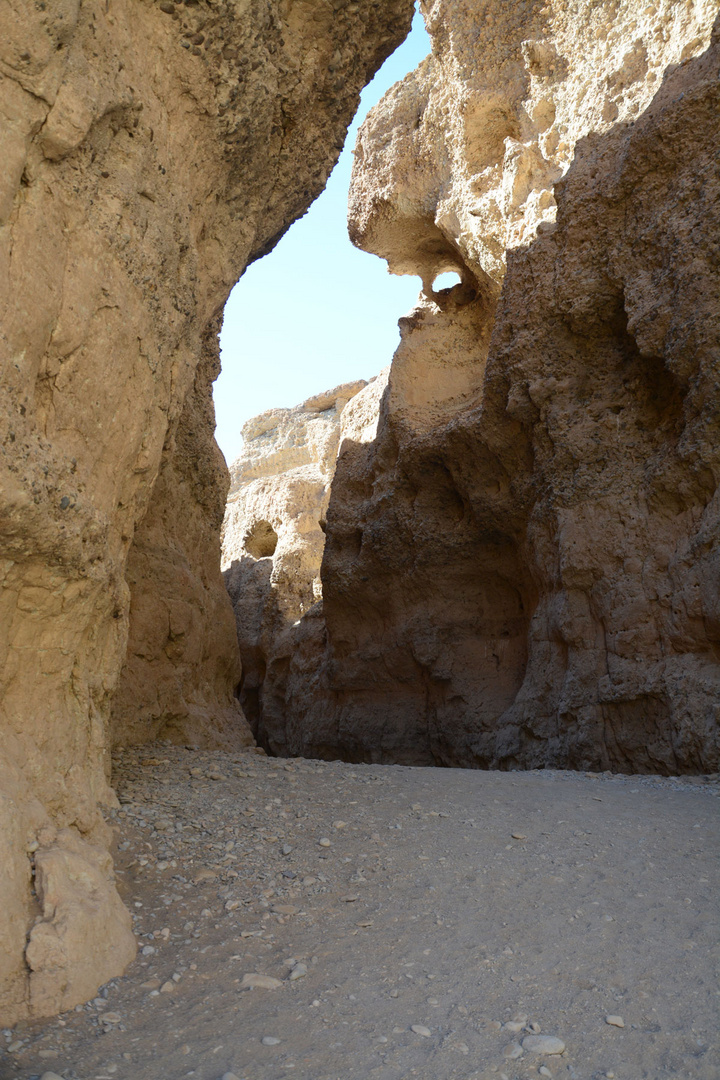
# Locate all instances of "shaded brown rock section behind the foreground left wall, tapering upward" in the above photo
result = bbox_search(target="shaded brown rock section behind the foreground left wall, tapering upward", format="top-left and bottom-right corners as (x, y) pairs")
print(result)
(106, 313), (252, 748)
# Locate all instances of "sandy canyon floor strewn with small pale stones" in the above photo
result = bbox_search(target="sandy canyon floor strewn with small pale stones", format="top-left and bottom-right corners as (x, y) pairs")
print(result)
(0, 745), (720, 1080)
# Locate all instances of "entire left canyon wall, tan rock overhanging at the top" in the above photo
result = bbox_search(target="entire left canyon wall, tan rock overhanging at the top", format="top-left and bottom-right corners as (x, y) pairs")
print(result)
(0, 0), (412, 1024)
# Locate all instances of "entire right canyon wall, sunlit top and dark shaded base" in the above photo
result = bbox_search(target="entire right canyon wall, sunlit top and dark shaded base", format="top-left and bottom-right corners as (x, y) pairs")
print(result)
(252, 0), (720, 773)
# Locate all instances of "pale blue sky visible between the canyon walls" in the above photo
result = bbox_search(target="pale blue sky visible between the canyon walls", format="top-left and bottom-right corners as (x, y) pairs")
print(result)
(214, 8), (430, 463)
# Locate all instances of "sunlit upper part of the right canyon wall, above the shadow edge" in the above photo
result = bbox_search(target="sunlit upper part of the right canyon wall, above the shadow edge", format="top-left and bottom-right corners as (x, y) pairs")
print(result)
(349, 0), (717, 297)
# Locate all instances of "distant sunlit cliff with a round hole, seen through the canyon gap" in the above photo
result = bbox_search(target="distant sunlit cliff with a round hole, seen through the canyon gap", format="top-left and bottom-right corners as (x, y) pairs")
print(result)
(222, 378), (388, 746)
